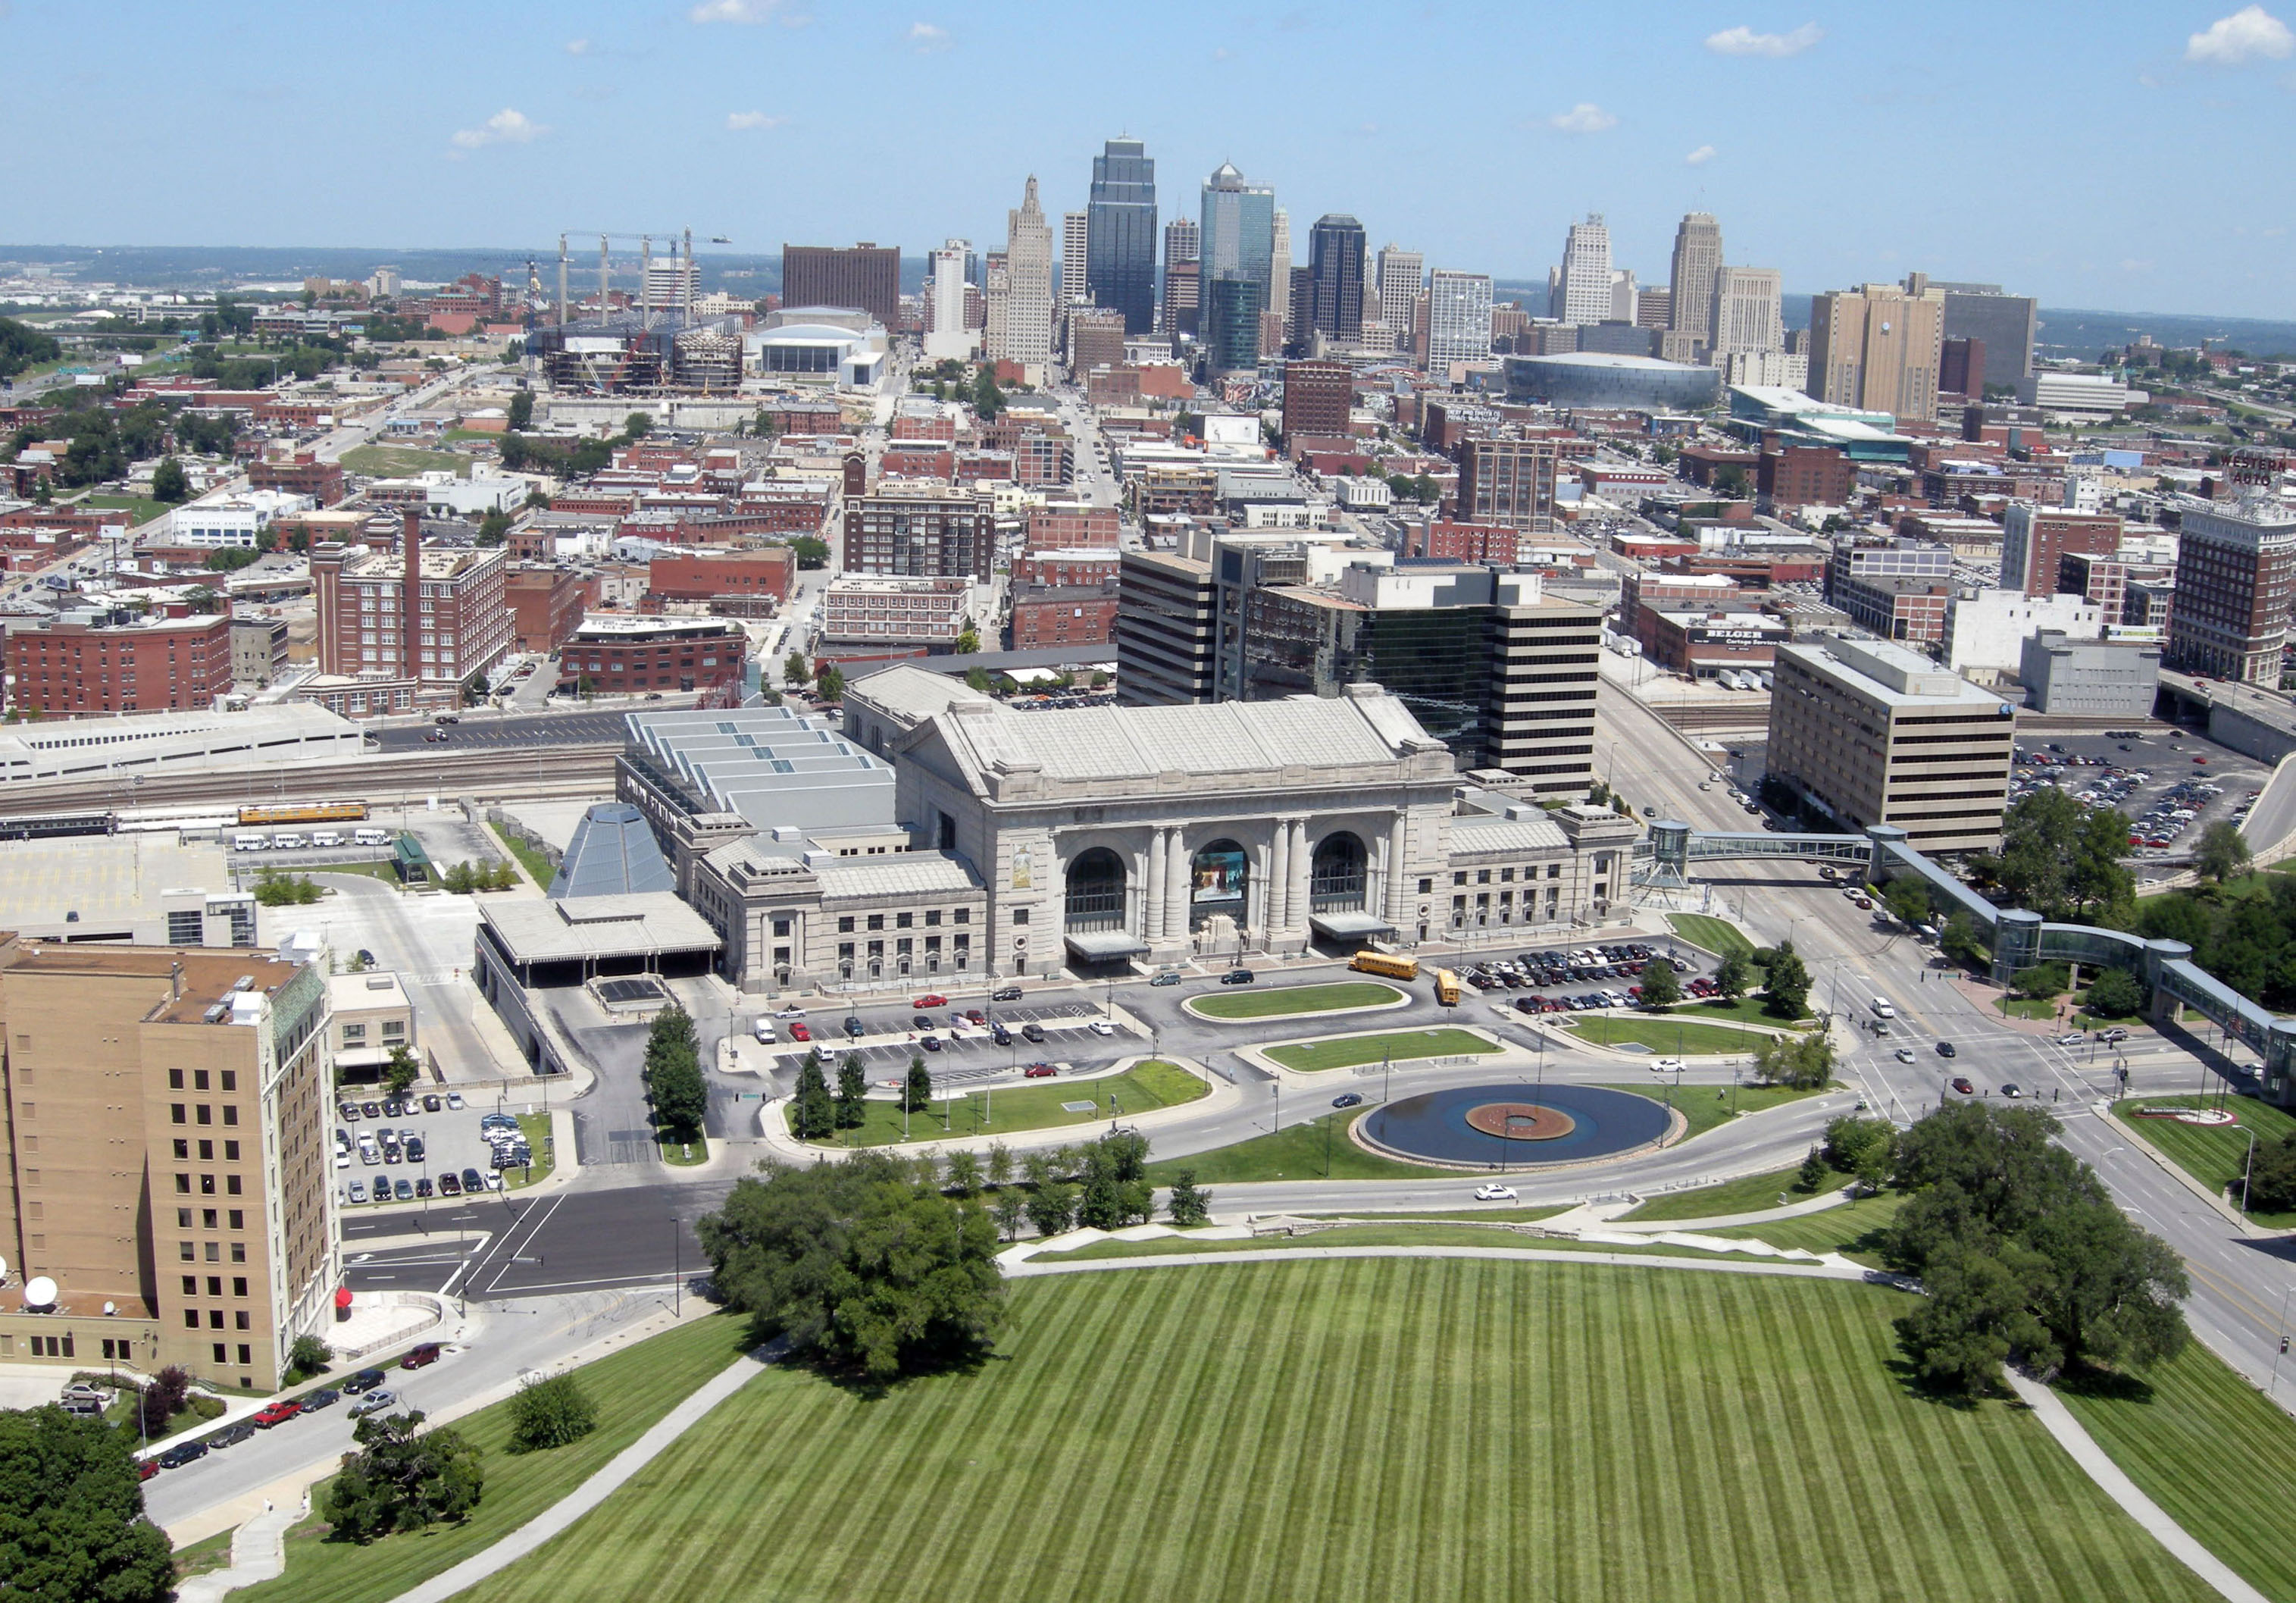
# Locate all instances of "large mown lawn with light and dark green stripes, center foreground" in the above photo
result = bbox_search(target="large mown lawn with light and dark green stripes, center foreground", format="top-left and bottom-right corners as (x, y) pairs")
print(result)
(475, 1261), (2213, 1603)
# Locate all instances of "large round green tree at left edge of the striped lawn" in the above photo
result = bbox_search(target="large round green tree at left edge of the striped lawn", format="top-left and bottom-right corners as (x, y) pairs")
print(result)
(700, 1153), (1003, 1382)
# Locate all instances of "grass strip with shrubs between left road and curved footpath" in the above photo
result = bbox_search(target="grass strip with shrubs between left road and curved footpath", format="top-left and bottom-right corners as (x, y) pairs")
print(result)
(232, 1316), (749, 1603)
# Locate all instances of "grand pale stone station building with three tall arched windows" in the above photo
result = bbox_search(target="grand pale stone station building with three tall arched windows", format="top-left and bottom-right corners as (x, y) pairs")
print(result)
(618, 666), (1639, 992)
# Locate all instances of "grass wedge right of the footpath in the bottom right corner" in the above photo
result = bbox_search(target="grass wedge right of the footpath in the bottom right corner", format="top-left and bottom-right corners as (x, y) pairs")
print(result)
(2057, 1342), (2296, 1598)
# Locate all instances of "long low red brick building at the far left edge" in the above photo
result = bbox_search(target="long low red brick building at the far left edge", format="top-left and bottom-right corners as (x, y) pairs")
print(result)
(7, 613), (232, 719)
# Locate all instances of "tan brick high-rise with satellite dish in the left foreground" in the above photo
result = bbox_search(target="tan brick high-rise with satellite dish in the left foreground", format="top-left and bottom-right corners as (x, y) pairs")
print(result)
(0, 935), (342, 1392)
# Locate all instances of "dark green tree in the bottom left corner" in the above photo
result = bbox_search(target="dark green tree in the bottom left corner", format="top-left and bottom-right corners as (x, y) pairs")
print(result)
(0, 1396), (174, 1603)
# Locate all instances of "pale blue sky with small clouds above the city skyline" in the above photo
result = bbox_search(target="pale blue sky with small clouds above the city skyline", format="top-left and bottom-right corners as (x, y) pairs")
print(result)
(0, 0), (2296, 317)
